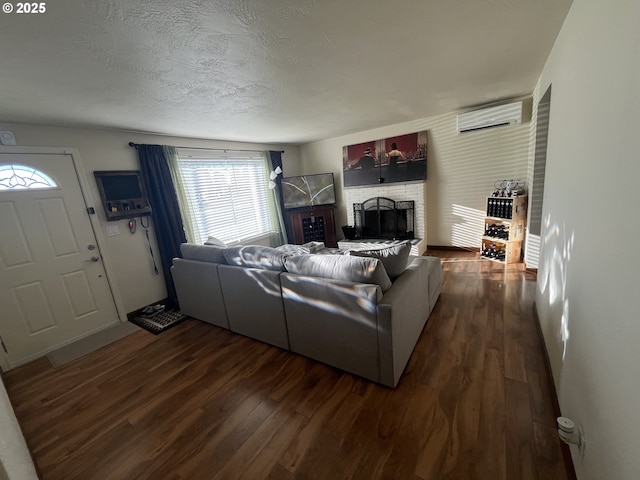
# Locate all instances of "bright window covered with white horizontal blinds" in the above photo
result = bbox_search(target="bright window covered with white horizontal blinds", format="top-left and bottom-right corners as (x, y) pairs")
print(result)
(178, 154), (275, 243)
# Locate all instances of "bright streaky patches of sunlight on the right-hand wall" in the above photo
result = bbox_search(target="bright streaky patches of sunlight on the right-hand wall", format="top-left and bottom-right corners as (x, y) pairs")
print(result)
(538, 215), (575, 386)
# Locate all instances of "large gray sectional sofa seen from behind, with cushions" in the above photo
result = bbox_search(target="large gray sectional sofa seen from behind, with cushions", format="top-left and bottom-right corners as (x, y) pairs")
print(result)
(172, 244), (441, 387)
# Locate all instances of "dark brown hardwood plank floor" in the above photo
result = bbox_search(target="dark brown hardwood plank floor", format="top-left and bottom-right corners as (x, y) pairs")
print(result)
(4, 250), (575, 480)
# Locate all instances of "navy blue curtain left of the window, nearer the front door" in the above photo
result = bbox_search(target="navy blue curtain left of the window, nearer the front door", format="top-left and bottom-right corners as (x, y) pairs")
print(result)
(136, 145), (187, 308)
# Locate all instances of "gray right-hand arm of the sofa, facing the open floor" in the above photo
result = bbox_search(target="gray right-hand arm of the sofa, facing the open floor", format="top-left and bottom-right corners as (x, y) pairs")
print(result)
(378, 257), (433, 387)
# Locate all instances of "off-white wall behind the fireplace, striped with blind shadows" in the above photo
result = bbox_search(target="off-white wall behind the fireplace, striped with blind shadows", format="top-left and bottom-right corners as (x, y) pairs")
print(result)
(300, 113), (529, 248)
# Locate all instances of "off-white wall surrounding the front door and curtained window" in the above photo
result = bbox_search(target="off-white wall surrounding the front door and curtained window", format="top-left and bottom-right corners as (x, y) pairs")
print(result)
(0, 123), (299, 312)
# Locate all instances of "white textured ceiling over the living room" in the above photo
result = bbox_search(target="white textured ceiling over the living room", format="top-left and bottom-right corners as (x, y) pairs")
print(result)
(0, 0), (571, 143)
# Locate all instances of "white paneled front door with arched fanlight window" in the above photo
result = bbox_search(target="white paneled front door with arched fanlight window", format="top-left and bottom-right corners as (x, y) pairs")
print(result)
(0, 152), (119, 367)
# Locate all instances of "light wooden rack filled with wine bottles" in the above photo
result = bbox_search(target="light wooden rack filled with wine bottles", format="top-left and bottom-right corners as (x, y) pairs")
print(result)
(480, 197), (527, 264)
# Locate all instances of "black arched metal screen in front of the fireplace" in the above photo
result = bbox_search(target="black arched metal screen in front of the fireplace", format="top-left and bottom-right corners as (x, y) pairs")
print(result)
(353, 197), (414, 240)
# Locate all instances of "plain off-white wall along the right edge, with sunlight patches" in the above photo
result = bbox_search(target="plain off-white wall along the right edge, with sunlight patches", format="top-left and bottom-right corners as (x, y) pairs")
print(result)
(536, 0), (640, 480)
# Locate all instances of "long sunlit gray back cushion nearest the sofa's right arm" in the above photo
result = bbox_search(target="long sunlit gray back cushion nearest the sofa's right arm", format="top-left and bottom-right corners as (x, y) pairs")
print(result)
(284, 255), (391, 292)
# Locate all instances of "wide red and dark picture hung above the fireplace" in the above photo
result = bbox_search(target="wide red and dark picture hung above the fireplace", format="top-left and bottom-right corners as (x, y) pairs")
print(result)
(342, 130), (428, 187)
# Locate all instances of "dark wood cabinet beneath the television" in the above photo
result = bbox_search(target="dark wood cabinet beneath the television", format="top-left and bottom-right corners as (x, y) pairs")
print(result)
(287, 206), (338, 248)
